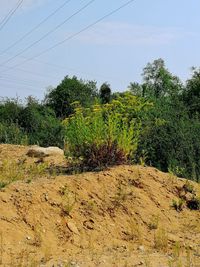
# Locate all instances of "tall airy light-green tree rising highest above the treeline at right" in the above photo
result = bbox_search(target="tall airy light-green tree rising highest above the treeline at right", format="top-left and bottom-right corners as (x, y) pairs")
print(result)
(142, 58), (182, 98)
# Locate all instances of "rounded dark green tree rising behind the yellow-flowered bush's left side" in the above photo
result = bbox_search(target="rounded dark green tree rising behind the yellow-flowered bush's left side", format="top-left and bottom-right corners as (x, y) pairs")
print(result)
(45, 76), (97, 118)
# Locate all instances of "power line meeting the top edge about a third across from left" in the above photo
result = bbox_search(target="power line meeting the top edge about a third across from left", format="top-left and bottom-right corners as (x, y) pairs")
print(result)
(0, 0), (72, 55)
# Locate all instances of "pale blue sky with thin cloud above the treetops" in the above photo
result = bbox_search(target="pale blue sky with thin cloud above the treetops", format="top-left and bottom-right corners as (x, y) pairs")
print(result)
(0, 0), (200, 99)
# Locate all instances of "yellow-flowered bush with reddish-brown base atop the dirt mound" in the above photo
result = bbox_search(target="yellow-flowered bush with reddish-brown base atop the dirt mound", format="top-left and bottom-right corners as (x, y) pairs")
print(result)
(64, 105), (139, 170)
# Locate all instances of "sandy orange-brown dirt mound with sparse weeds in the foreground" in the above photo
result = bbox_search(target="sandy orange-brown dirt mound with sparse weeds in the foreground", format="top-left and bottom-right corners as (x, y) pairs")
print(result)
(0, 145), (200, 267)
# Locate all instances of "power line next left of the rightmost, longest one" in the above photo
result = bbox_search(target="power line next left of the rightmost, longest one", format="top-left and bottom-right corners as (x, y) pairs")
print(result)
(0, 0), (96, 66)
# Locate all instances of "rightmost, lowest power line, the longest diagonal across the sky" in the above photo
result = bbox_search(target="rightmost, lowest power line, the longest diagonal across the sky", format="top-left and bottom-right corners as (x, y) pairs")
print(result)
(0, 0), (135, 72)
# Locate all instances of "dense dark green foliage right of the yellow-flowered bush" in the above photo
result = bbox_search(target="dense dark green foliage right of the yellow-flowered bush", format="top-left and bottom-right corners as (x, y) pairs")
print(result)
(138, 92), (200, 181)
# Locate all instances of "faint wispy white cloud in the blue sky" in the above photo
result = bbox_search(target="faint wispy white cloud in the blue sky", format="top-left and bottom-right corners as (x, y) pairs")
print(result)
(76, 22), (190, 46)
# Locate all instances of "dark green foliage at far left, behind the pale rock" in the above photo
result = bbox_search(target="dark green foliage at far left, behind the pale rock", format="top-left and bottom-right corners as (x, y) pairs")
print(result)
(0, 96), (64, 147)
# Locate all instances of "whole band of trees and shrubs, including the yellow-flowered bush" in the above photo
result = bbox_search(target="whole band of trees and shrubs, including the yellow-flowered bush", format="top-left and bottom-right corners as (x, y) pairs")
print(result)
(0, 59), (200, 181)
